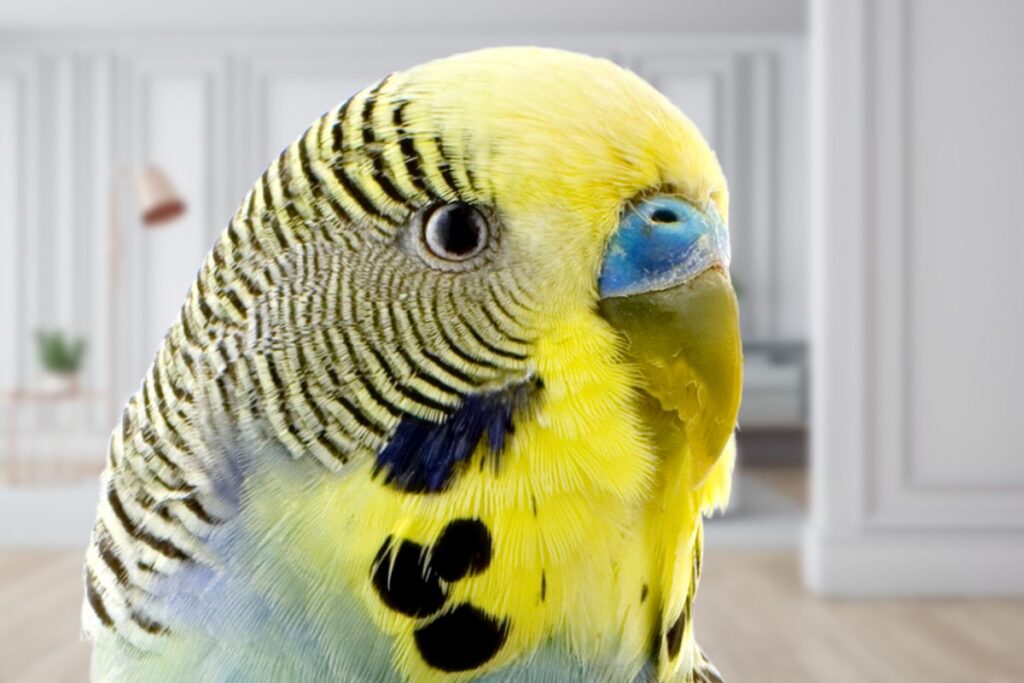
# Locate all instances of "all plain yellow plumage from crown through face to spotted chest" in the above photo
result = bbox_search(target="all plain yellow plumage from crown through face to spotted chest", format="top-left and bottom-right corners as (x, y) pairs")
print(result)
(242, 49), (734, 681)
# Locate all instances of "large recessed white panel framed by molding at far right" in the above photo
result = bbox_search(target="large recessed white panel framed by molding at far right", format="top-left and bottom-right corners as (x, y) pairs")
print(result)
(904, 1), (1024, 495)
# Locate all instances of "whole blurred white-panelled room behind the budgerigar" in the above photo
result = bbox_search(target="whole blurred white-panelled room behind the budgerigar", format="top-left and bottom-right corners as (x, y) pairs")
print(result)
(0, 0), (1024, 681)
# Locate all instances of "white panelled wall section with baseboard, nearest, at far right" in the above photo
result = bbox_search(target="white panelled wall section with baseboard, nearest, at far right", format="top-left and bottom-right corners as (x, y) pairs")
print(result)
(805, 0), (1024, 594)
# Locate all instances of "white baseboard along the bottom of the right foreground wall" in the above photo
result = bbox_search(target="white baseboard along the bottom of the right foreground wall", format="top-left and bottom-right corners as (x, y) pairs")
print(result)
(803, 525), (1024, 597)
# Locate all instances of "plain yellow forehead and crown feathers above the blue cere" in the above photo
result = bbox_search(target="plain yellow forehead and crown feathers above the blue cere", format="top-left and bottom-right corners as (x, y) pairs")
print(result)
(388, 47), (727, 239)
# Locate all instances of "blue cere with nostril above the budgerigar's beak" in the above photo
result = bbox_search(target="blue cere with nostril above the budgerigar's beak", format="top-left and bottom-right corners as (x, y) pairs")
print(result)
(597, 197), (729, 298)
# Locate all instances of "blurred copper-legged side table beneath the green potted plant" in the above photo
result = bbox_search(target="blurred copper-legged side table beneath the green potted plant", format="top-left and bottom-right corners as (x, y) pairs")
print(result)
(0, 388), (110, 486)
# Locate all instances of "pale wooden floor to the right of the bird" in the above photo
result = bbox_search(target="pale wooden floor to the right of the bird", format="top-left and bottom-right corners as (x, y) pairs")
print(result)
(696, 549), (1024, 683)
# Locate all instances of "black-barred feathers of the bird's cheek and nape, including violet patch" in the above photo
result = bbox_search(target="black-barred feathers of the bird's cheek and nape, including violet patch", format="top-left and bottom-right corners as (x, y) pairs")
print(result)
(85, 66), (538, 650)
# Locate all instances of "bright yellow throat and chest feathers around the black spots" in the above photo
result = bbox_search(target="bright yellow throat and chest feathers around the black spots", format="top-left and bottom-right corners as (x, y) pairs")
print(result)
(243, 314), (734, 681)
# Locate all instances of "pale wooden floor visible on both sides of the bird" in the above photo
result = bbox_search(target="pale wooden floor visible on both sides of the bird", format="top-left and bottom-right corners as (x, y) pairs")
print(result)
(0, 549), (1024, 683)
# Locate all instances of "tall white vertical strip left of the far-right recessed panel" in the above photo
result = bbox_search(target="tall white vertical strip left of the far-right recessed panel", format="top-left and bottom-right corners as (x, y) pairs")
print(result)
(810, 0), (868, 535)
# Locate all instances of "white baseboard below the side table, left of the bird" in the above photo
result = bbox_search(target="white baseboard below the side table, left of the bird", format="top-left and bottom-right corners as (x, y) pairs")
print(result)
(0, 480), (99, 550)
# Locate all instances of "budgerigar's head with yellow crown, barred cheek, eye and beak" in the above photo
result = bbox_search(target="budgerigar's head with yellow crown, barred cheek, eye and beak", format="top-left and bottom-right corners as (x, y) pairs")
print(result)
(225, 48), (739, 485)
